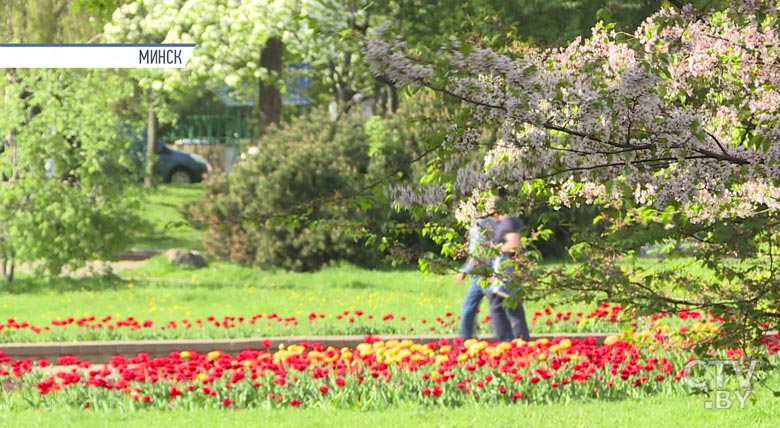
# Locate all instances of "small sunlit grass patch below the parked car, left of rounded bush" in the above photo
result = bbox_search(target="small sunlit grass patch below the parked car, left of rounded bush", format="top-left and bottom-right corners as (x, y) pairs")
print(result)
(130, 184), (203, 250)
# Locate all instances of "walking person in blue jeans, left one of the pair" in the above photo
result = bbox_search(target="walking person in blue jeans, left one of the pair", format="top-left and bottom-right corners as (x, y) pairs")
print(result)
(455, 197), (496, 340)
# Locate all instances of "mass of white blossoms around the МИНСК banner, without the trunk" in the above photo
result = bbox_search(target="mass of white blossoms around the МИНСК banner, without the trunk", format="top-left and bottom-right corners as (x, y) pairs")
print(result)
(103, 0), (367, 98)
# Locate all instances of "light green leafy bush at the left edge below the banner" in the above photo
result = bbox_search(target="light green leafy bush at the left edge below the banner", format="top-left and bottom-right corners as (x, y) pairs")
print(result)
(0, 70), (140, 280)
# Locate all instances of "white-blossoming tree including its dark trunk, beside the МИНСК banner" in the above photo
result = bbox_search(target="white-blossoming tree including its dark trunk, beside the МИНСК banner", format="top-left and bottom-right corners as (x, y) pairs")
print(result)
(104, 0), (330, 136)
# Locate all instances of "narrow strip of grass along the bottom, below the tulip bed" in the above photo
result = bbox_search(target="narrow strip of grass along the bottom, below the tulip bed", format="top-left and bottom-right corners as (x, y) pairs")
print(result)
(0, 392), (780, 428)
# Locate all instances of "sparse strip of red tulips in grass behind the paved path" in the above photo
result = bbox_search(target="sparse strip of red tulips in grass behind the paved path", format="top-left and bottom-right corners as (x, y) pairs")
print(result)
(0, 303), (722, 343)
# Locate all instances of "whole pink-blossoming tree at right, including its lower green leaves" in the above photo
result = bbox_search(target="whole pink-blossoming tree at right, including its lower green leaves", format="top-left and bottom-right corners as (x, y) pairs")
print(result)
(366, 0), (780, 352)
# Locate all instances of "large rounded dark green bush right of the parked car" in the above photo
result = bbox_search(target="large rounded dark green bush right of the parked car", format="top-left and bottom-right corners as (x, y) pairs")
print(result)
(185, 96), (442, 270)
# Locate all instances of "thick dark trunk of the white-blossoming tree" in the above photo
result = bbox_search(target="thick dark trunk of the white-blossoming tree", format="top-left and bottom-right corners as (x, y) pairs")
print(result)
(257, 38), (284, 137)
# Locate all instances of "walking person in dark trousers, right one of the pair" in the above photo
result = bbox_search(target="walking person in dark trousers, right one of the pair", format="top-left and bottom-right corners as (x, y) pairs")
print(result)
(486, 214), (531, 342)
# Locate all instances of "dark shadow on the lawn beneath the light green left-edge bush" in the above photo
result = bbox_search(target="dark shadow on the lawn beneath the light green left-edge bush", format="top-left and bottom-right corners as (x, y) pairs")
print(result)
(0, 274), (130, 294)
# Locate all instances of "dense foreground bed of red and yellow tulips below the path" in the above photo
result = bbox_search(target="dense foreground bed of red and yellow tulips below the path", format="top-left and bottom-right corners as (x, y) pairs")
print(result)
(0, 335), (777, 409)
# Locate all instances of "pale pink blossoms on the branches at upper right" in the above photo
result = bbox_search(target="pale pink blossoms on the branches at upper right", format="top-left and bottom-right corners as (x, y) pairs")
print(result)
(366, 0), (780, 223)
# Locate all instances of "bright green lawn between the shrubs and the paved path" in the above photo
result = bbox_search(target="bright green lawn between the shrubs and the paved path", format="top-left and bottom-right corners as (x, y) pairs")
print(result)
(0, 256), (614, 342)
